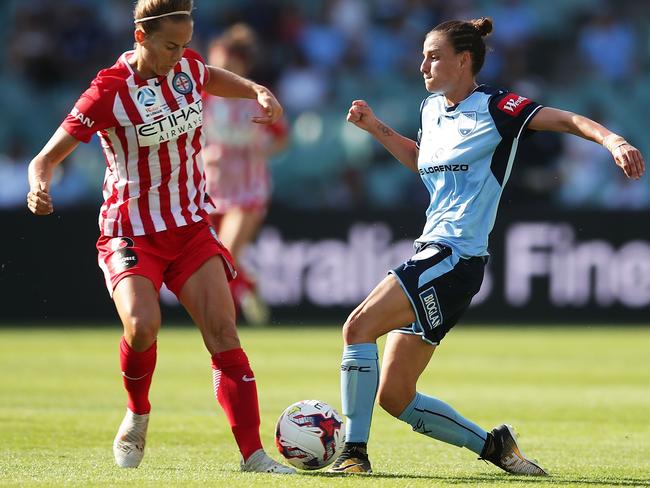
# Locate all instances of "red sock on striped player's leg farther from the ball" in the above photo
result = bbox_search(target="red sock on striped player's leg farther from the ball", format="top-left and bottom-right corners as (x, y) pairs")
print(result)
(120, 337), (156, 415)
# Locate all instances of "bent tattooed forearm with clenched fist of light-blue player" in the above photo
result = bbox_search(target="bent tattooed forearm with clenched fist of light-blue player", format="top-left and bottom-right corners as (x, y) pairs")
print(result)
(347, 100), (419, 173)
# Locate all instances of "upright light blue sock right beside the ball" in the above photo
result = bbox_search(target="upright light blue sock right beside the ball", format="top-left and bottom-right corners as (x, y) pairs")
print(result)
(341, 343), (379, 443)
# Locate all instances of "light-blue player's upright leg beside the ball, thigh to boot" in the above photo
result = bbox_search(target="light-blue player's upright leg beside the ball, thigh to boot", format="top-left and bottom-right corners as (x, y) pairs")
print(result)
(330, 276), (415, 473)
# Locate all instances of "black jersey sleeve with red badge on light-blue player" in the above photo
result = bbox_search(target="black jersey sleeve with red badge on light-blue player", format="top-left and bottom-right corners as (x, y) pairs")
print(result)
(489, 91), (542, 139)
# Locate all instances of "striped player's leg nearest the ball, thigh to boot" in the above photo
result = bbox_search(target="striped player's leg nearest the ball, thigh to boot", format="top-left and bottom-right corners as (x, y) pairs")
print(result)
(178, 256), (295, 474)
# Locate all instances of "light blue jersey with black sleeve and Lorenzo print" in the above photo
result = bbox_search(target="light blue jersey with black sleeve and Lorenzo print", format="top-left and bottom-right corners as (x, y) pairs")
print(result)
(416, 85), (541, 258)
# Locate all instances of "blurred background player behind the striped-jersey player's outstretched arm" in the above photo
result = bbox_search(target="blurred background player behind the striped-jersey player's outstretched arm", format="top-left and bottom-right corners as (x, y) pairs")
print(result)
(203, 23), (287, 325)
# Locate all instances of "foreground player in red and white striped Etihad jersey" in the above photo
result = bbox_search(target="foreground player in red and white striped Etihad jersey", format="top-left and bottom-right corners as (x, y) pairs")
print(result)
(27, 0), (295, 473)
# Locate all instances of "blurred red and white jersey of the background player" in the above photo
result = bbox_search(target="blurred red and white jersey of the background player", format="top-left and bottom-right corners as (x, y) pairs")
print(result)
(203, 94), (287, 213)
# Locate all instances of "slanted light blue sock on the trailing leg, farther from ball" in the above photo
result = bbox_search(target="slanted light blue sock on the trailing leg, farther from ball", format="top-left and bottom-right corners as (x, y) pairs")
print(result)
(398, 393), (487, 455)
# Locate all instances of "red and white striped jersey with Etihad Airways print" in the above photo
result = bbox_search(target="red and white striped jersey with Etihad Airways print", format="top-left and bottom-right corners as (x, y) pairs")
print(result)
(61, 49), (212, 236)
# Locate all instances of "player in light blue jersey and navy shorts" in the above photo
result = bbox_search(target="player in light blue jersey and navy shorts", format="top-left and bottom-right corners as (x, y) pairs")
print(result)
(332, 18), (644, 476)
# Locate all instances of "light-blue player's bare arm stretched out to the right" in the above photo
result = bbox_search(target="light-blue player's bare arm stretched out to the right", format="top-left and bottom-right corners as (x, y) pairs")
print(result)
(528, 107), (645, 180)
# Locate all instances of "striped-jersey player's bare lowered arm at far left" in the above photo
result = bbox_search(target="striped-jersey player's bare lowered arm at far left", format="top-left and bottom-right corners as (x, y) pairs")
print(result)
(27, 127), (79, 215)
